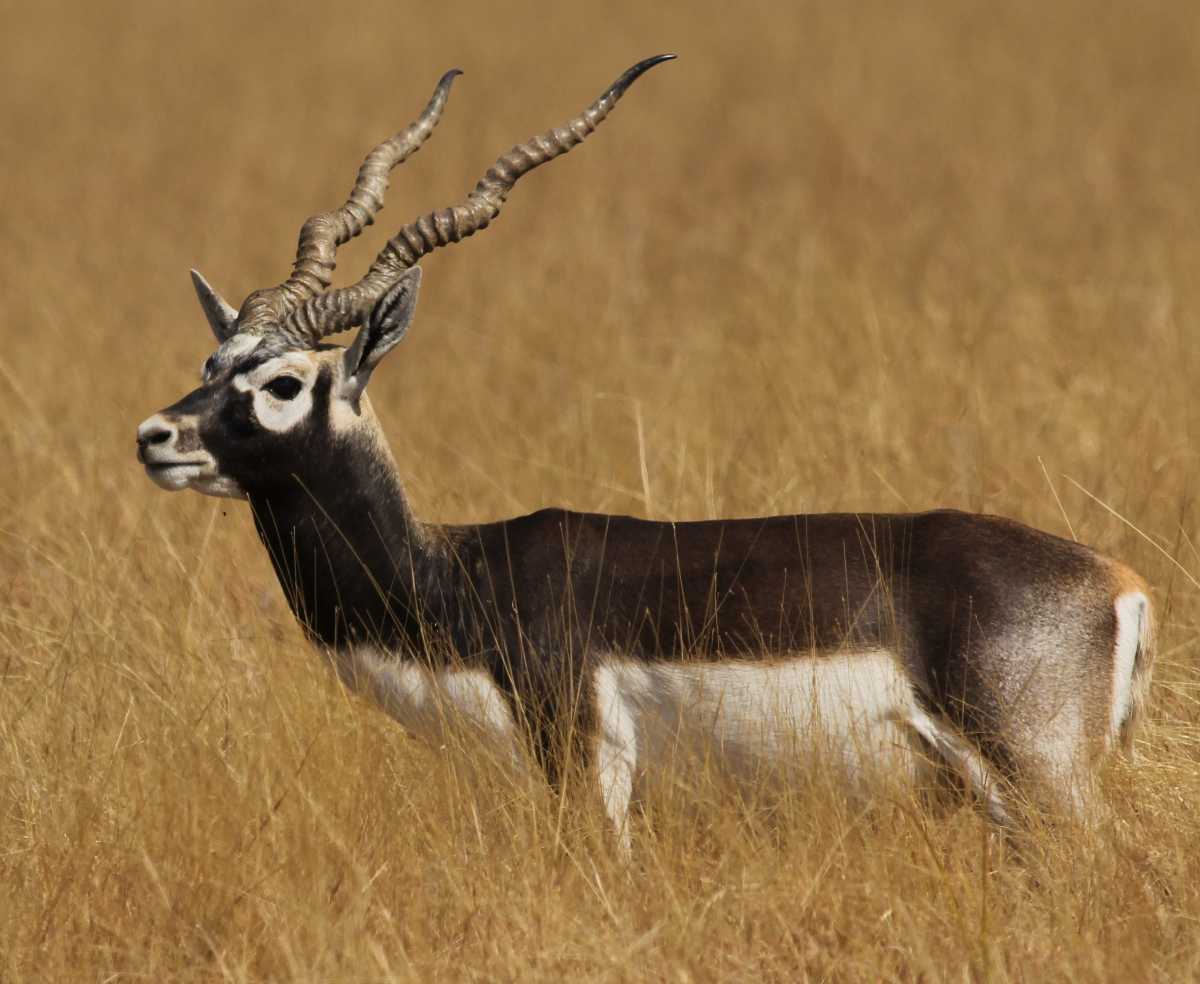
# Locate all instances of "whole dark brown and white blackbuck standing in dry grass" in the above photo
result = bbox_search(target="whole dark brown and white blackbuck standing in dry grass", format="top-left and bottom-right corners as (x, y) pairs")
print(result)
(137, 55), (1153, 850)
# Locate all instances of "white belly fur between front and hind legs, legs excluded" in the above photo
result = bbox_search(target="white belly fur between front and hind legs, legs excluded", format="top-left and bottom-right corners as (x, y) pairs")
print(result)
(594, 649), (914, 779)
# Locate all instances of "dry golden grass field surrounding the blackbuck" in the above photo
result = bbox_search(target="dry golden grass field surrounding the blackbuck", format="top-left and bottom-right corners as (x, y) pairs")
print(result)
(0, 0), (1200, 984)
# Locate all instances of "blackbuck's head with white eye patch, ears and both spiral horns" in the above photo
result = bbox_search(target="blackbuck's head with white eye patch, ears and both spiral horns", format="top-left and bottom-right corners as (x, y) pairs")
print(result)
(137, 55), (674, 498)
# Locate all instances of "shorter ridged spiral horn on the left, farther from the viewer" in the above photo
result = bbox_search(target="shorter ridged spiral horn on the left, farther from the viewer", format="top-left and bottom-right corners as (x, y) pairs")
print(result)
(238, 68), (462, 334)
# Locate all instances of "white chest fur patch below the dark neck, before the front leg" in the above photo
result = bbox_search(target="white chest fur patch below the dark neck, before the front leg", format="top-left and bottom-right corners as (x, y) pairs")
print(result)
(337, 646), (522, 763)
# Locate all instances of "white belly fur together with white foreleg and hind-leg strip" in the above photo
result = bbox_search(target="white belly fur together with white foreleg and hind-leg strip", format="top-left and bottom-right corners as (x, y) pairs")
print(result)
(592, 649), (993, 851)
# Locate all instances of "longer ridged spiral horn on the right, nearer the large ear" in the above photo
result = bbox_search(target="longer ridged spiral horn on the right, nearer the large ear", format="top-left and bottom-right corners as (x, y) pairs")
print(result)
(282, 54), (674, 344)
